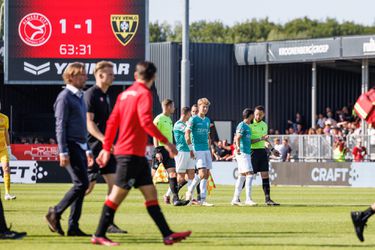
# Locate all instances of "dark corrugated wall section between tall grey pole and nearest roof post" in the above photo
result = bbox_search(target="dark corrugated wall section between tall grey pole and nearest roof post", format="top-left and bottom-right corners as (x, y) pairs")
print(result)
(190, 44), (264, 127)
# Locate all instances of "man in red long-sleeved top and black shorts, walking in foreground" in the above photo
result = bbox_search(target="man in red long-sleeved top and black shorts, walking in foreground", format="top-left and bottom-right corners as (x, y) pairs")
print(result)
(91, 61), (191, 246)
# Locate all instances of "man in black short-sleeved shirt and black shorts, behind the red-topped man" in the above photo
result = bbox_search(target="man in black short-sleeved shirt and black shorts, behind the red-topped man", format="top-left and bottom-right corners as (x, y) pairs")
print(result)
(84, 61), (127, 233)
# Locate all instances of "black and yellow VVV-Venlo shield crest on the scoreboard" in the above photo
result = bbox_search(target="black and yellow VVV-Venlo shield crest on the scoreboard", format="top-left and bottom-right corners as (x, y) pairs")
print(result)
(111, 15), (139, 46)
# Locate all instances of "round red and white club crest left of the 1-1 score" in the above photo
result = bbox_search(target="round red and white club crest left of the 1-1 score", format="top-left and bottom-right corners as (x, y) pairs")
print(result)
(18, 12), (52, 47)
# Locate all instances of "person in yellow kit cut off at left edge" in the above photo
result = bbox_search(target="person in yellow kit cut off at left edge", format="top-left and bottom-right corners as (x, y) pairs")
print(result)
(0, 113), (16, 200)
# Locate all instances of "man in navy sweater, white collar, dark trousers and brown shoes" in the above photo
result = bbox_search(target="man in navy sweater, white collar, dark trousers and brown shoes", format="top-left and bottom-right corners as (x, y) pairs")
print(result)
(46, 62), (94, 236)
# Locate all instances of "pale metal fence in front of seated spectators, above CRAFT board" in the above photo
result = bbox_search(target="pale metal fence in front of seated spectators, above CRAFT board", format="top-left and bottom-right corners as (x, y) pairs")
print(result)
(269, 135), (375, 161)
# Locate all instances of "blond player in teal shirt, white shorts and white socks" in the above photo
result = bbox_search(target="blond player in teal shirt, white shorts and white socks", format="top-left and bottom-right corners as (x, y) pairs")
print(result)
(185, 98), (213, 207)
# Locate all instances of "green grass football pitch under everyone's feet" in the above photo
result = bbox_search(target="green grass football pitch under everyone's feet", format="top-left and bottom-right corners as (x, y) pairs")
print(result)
(0, 184), (375, 250)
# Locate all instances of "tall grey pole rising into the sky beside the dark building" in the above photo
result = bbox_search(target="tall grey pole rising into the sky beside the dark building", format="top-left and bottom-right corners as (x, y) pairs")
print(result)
(181, 0), (190, 107)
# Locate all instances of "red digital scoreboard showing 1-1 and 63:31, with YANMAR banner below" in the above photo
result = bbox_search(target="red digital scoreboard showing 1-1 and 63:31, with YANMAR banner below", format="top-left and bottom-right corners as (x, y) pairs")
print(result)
(4, 0), (146, 84)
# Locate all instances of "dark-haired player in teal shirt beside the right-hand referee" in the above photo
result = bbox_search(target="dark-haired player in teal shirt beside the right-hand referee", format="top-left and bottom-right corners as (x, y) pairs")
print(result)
(231, 108), (256, 206)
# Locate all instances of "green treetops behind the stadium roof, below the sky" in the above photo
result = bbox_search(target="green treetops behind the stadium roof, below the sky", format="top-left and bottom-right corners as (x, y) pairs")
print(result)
(150, 17), (375, 43)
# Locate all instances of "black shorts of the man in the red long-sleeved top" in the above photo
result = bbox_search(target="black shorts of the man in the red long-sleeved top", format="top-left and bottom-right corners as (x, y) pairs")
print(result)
(115, 155), (153, 190)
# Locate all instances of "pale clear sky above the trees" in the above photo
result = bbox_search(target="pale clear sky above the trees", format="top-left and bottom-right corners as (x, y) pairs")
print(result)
(149, 0), (375, 25)
